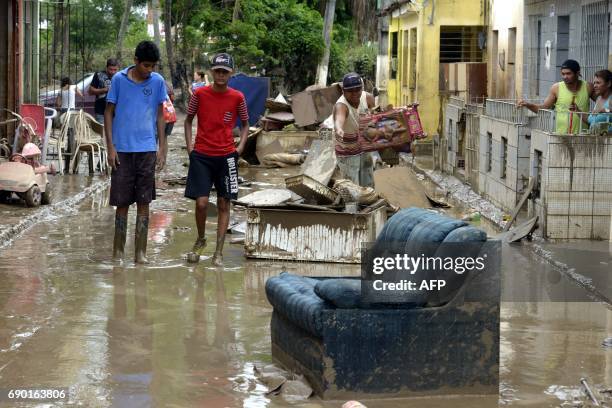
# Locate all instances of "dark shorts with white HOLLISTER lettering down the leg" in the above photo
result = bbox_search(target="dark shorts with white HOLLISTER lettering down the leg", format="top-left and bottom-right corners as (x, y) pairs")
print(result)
(185, 150), (238, 200)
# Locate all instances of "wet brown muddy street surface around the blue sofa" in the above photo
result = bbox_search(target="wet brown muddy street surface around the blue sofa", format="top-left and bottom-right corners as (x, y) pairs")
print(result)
(0, 121), (612, 408)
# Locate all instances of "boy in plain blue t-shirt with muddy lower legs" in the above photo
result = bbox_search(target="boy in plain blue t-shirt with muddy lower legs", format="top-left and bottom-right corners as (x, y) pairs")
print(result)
(104, 41), (168, 263)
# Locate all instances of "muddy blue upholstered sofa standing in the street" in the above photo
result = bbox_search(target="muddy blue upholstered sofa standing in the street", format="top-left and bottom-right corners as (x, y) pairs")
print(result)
(266, 208), (500, 399)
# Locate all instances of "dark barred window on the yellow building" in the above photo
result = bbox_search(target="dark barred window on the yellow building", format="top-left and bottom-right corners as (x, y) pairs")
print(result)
(440, 26), (484, 63)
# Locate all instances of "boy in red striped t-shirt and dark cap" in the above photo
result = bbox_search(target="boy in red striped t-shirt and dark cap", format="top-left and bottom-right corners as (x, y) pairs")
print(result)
(185, 53), (249, 266)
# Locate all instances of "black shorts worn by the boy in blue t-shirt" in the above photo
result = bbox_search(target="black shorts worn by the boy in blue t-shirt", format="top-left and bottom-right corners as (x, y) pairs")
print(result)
(110, 152), (157, 207)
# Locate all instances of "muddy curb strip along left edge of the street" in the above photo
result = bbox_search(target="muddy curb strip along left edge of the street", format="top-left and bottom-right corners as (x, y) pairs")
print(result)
(0, 178), (110, 249)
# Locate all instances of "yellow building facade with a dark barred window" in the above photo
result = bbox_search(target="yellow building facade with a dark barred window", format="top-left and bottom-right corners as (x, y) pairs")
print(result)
(387, 0), (488, 135)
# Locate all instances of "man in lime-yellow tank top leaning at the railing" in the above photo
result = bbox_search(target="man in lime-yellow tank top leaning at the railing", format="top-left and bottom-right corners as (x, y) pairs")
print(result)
(517, 59), (595, 134)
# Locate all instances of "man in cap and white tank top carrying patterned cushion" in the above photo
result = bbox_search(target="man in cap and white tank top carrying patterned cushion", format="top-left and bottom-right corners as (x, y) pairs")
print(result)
(333, 72), (374, 186)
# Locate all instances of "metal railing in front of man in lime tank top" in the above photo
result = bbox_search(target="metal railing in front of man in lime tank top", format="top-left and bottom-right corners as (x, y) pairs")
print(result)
(535, 109), (612, 135)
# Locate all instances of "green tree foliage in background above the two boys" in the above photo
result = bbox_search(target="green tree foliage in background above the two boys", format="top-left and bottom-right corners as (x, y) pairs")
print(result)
(41, 0), (376, 92)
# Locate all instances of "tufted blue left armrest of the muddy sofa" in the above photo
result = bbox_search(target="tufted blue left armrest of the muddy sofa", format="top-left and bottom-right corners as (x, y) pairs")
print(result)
(266, 272), (326, 337)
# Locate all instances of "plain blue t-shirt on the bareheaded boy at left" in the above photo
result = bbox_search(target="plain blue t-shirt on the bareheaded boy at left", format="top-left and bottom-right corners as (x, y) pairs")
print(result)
(106, 65), (168, 153)
